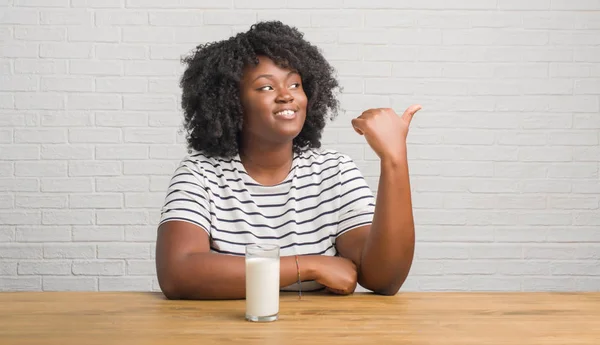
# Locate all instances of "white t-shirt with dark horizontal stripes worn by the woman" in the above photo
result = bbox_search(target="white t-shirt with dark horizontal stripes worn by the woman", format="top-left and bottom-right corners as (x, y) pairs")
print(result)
(160, 150), (375, 256)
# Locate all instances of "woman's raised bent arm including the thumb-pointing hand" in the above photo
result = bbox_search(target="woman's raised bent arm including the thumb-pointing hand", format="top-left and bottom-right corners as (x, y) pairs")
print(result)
(336, 106), (420, 295)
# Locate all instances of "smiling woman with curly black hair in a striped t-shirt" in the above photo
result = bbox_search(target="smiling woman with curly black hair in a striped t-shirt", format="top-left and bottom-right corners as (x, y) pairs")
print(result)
(156, 22), (420, 299)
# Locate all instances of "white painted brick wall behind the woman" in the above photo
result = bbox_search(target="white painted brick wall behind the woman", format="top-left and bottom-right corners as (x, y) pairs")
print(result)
(0, 0), (600, 291)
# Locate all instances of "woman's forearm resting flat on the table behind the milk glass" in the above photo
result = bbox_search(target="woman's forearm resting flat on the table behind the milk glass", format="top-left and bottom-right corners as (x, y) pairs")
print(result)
(159, 252), (314, 299)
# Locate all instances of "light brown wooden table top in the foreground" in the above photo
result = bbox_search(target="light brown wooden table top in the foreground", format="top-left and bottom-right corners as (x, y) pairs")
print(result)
(0, 292), (600, 345)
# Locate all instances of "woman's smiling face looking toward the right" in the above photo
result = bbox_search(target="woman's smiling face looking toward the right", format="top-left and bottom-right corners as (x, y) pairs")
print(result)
(240, 56), (308, 144)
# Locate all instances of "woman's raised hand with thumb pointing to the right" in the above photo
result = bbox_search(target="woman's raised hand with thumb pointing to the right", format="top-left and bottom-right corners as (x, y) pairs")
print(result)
(352, 105), (421, 160)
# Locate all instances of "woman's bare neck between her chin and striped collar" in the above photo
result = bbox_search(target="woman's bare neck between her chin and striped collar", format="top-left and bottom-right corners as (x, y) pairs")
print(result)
(240, 142), (293, 185)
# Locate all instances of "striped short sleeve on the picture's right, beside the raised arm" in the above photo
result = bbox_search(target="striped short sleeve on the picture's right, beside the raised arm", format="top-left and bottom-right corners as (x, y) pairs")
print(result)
(336, 156), (375, 237)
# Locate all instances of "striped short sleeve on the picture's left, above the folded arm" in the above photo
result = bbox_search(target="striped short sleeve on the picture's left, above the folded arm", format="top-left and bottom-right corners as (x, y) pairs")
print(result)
(159, 160), (210, 235)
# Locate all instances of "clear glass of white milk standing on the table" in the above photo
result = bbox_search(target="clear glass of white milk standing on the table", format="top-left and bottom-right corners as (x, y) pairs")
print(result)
(246, 244), (279, 322)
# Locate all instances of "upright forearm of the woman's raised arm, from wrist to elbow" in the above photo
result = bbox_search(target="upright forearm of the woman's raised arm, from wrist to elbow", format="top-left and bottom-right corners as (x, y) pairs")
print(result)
(358, 155), (415, 295)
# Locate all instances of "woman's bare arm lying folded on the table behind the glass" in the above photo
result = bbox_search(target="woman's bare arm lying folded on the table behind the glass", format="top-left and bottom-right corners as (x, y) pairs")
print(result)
(156, 221), (356, 299)
